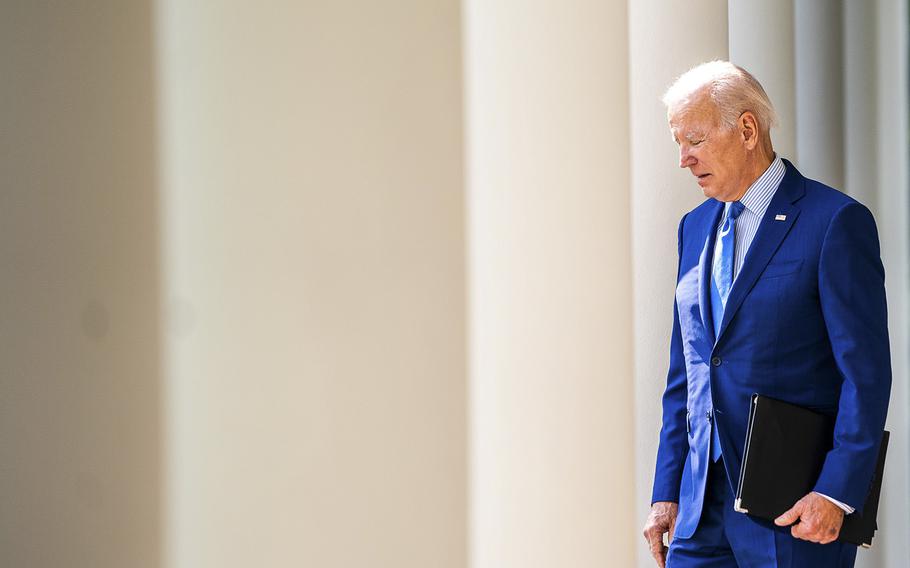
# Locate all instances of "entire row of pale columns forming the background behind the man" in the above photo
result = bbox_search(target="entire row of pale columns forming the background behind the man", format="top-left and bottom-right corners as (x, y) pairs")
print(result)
(0, 0), (910, 568)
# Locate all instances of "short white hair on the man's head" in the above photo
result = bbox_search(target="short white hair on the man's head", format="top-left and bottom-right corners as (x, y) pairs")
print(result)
(663, 60), (777, 133)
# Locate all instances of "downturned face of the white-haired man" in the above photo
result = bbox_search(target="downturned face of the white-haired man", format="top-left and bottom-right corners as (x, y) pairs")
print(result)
(668, 95), (749, 201)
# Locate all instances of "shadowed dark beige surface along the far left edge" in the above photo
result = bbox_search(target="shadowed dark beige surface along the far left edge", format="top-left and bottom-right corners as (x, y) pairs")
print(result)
(0, 0), (161, 568)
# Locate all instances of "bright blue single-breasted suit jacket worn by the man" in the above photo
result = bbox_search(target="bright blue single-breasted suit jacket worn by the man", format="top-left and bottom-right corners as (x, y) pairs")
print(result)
(652, 160), (891, 538)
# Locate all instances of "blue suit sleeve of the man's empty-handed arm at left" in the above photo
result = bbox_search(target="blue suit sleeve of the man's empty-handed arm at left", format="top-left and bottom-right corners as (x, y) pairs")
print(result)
(651, 216), (689, 505)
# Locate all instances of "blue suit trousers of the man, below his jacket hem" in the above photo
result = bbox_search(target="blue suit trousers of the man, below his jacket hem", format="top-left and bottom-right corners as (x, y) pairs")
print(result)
(667, 459), (856, 568)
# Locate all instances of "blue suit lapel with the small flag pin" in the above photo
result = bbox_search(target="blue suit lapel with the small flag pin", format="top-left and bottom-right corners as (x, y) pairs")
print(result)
(720, 160), (805, 339)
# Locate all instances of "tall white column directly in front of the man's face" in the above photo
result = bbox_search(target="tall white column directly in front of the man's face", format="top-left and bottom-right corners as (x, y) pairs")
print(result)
(629, 0), (727, 567)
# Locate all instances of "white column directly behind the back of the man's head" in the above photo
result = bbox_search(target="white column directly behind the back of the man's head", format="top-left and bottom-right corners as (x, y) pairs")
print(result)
(727, 0), (796, 160)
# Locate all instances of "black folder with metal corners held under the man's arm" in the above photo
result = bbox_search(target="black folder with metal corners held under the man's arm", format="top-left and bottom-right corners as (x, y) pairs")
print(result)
(734, 394), (890, 548)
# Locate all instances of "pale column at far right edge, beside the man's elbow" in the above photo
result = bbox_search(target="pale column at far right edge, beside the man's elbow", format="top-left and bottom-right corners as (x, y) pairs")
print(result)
(876, 0), (910, 568)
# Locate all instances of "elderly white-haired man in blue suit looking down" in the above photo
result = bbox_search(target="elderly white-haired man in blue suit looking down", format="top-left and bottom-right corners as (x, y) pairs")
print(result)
(644, 61), (891, 568)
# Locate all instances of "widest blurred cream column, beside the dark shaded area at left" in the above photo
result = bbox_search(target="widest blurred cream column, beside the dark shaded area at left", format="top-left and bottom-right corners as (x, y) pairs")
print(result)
(157, 0), (467, 568)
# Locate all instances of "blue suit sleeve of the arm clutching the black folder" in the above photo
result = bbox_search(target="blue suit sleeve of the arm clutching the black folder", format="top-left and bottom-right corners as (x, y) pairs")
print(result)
(814, 202), (891, 513)
